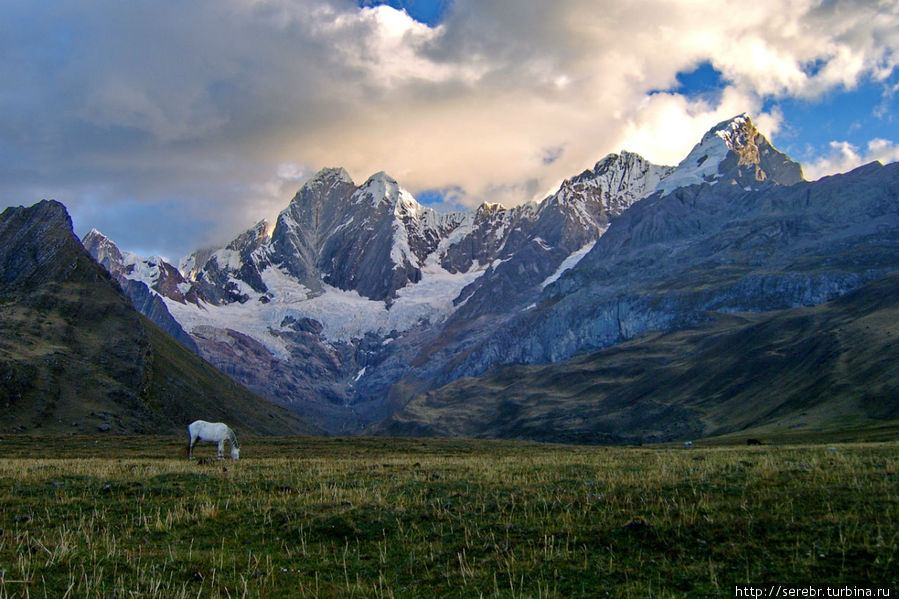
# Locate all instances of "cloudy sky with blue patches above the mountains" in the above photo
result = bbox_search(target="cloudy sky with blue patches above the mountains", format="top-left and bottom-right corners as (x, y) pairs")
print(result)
(0, 0), (899, 263)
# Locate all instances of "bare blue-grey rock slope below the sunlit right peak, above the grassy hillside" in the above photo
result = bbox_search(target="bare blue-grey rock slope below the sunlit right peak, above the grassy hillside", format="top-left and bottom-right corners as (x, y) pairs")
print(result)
(402, 159), (899, 394)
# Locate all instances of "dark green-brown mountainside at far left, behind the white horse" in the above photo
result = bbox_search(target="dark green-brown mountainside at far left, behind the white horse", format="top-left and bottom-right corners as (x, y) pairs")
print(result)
(0, 201), (316, 434)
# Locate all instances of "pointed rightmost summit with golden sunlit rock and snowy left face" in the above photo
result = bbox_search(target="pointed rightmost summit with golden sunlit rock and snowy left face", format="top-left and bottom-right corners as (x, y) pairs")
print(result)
(659, 113), (804, 193)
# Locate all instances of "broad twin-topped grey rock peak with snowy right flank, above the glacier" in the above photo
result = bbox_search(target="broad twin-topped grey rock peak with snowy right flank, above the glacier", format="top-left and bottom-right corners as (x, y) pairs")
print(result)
(262, 168), (442, 300)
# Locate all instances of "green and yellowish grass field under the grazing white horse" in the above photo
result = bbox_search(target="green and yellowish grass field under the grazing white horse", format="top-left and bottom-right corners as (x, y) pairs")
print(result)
(0, 436), (899, 598)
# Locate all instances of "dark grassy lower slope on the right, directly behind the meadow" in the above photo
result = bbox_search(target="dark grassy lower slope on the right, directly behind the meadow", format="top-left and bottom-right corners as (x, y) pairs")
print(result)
(371, 274), (899, 443)
